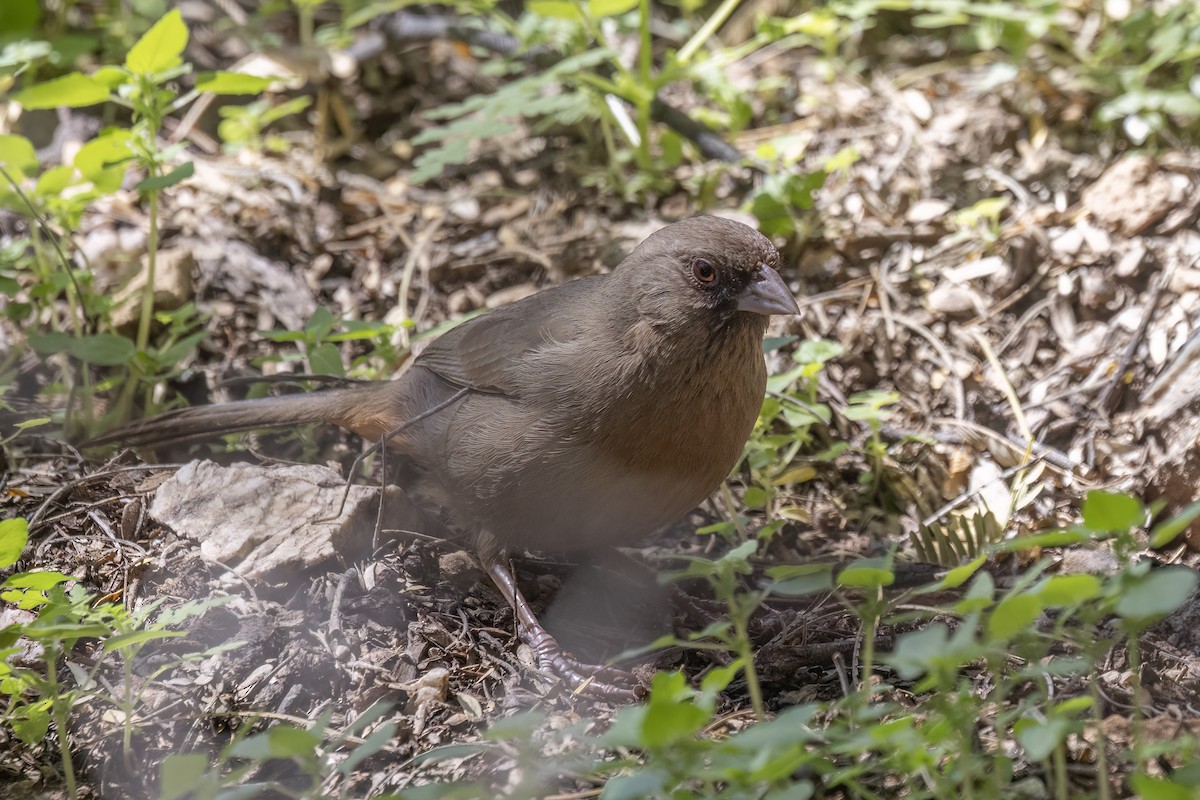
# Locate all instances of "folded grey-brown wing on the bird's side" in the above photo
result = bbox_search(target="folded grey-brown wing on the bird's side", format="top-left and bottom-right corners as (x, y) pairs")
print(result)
(414, 276), (604, 397)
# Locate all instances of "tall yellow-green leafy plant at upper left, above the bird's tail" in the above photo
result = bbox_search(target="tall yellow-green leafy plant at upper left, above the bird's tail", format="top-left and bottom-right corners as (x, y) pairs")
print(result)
(0, 11), (272, 427)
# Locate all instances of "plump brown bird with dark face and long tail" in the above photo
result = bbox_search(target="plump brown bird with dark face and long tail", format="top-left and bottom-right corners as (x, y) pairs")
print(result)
(94, 217), (798, 686)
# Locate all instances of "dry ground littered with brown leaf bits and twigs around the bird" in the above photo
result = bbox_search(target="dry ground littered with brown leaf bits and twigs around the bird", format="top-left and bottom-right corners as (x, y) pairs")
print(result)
(0, 7), (1200, 798)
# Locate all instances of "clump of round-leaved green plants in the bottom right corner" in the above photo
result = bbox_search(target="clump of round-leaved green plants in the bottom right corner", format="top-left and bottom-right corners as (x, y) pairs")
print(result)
(887, 492), (1200, 798)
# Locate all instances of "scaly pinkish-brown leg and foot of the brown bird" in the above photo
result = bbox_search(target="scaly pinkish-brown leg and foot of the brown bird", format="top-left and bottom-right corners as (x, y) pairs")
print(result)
(480, 553), (638, 703)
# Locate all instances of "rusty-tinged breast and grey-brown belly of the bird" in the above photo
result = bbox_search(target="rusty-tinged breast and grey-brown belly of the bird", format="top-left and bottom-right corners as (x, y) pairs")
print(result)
(427, 316), (767, 552)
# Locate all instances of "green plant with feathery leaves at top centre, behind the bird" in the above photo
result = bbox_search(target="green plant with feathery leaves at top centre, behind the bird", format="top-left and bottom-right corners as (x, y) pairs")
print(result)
(413, 0), (768, 196)
